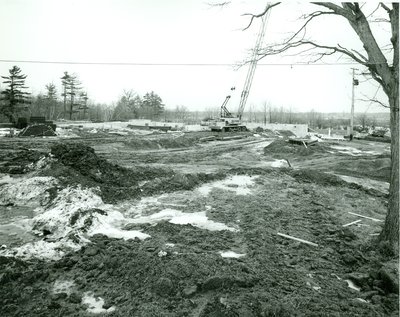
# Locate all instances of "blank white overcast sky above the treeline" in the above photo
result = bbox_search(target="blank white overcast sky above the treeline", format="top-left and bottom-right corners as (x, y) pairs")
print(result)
(0, 0), (390, 112)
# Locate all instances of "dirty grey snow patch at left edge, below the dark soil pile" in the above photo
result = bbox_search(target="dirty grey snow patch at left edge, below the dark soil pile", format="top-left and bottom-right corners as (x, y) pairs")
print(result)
(0, 176), (57, 206)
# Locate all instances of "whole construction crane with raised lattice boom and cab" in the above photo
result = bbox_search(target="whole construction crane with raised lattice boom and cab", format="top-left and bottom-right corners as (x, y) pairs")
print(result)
(211, 10), (271, 132)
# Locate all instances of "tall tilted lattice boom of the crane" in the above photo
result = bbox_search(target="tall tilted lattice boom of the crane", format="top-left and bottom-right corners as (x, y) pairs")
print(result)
(237, 10), (271, 120)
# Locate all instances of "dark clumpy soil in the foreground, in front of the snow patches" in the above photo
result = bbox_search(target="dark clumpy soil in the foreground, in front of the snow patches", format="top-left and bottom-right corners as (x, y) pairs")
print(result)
(0, 167), (398, 317)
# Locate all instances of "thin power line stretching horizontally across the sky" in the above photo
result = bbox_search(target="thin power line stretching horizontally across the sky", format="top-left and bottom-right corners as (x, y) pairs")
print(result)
(0, 59), (378, 67)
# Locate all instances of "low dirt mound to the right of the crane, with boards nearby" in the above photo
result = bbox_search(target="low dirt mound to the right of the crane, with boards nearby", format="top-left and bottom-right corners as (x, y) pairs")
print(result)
(264, 140), (327, 158)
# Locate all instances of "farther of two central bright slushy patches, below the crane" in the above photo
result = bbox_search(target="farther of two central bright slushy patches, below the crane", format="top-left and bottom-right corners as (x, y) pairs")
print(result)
(196, 175), (258, 196)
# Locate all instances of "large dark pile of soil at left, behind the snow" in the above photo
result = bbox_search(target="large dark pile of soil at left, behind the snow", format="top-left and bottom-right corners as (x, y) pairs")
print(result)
(41, 143), (224, 203)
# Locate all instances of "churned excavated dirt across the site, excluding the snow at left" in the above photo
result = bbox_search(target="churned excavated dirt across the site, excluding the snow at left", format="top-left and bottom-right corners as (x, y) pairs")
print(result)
(0, 130), (398, 317)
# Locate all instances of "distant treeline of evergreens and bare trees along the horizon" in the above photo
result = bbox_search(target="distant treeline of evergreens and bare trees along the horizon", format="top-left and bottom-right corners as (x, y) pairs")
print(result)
(0, 66), (389, 129)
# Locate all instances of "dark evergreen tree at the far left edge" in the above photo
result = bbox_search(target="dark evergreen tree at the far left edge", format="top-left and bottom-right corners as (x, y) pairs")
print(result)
(0, 66), (30, 123)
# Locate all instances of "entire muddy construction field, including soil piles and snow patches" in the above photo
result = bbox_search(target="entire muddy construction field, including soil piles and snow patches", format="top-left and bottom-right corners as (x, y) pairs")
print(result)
(0, 129), (398, 317)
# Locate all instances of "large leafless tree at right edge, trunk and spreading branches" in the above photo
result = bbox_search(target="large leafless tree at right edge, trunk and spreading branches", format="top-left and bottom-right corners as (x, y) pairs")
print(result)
(245, 2), (399, 249)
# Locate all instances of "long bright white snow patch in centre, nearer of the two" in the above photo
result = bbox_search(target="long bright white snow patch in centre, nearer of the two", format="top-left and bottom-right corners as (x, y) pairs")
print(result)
(130, 208), (237, 231)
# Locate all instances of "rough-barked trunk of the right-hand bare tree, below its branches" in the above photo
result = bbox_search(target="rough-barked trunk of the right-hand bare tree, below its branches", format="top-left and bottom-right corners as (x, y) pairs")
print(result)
(379, 81), (400, 254)
